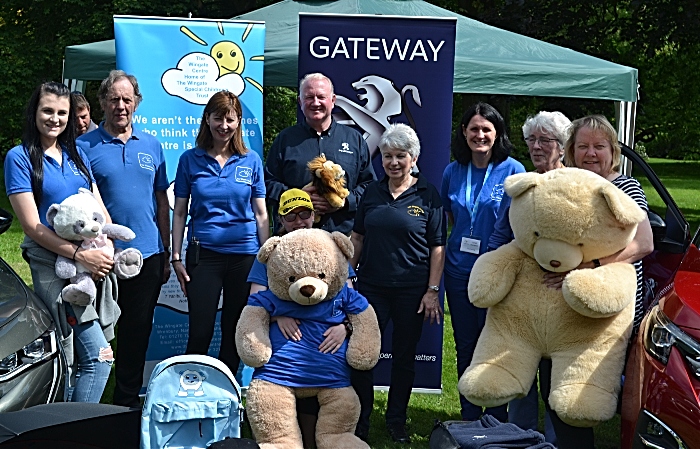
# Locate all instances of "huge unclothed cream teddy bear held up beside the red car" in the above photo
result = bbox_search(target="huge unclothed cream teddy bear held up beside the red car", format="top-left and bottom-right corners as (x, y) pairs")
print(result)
(458, 168), (645, 427)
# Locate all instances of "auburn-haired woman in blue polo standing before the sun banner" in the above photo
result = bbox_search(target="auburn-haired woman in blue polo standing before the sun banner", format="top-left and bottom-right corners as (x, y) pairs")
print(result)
(172, 91), (270, 373)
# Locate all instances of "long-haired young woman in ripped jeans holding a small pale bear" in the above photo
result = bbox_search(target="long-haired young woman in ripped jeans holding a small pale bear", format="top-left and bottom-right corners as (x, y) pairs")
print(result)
(5, 82), (114, 402)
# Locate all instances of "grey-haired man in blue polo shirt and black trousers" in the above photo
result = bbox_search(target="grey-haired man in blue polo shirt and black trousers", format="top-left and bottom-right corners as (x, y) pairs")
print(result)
(77, 70), (170, 407)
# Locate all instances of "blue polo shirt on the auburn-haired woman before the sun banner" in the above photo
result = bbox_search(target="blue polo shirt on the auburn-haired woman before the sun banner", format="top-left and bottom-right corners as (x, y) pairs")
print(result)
(175, 148), (265, 254)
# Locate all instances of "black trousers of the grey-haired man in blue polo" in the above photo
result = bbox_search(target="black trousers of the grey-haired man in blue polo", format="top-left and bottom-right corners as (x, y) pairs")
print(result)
(113, 253), (165, 407)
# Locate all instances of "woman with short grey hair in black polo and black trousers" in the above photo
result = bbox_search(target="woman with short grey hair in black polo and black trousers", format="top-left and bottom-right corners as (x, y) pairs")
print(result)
(350, 124), (446, 443)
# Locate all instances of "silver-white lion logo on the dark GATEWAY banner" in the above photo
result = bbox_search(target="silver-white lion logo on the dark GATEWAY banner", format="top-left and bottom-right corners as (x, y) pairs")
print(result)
(333, 75), (422, 157)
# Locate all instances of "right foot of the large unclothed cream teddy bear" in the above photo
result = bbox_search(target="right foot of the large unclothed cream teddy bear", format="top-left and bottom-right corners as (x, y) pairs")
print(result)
(549, 384), (617, 427)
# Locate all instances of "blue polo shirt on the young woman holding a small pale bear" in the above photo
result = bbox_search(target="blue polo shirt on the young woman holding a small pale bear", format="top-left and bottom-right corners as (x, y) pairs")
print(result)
(5, 145), (95, 229)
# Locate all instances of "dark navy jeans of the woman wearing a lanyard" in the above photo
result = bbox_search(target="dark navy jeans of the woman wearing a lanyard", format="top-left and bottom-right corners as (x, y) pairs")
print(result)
(444, 273), (508, 422)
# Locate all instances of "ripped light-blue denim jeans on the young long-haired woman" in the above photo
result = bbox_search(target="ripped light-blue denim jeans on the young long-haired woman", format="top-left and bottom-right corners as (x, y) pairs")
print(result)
(66, 305), (114, 403)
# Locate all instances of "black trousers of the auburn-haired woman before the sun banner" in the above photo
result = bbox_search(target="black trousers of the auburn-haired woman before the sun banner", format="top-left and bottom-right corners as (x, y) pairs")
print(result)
(186, 248), (255, 373)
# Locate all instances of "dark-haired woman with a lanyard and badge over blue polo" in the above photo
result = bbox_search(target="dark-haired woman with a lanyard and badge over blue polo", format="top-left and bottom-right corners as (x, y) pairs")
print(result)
(440, 103), (525, 421)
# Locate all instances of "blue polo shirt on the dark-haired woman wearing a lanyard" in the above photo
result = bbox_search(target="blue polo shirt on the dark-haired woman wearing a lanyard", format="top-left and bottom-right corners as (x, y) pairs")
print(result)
(440, 157), (525, 280)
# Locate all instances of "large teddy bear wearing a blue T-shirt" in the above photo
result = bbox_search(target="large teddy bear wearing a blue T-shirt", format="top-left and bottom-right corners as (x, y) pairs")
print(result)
(236, 229), (381, 449)
